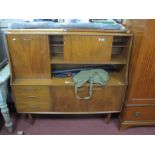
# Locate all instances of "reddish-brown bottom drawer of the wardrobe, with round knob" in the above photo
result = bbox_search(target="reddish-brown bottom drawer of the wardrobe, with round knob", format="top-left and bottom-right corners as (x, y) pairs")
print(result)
(122, 106), (155, 121)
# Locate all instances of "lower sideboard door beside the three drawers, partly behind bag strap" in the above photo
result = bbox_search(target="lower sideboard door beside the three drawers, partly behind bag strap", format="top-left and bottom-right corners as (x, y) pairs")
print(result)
(51, 86), (88, 112)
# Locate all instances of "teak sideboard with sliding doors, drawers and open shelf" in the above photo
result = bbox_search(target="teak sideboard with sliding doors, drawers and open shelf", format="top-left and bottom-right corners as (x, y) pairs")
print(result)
(6, 29), (132, 121)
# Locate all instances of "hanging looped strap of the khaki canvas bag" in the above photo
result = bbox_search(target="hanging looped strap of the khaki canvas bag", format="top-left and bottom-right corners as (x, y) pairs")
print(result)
(75, 80), (93, 100)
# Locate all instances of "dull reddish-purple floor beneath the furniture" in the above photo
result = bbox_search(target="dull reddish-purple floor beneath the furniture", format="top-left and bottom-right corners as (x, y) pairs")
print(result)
(0, 114), (155, 135)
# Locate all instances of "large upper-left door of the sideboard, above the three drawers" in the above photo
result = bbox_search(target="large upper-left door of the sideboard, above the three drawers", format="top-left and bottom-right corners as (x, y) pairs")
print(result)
(7, 35), (50, 78)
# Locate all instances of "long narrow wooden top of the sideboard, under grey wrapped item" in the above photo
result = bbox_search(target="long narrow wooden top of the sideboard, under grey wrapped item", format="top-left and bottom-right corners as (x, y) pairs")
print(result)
(6, 29), (132, 36)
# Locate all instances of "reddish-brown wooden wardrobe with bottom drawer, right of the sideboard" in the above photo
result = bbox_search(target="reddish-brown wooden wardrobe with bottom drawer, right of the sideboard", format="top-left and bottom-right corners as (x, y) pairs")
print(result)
(120, 20), (155, 129)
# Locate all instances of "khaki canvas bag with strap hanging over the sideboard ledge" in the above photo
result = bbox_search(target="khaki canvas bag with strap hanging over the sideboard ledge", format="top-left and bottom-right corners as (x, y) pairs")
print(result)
(73, 69), (109, 100)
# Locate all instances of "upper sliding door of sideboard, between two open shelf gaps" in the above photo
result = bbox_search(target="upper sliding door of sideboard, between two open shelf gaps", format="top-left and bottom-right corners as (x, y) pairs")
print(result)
(64, 35), (113, 62)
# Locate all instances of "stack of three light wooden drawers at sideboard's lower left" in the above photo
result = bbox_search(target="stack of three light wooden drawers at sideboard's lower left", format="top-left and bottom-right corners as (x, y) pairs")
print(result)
(12, 86), (52, 112)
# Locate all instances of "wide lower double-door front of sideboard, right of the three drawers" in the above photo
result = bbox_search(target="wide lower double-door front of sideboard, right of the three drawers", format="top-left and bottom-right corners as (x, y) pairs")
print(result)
(51, 86), (125, 112)
